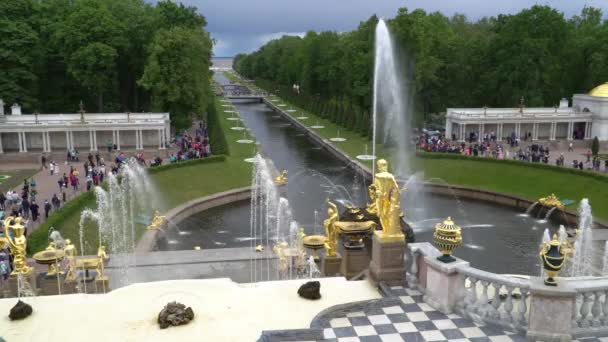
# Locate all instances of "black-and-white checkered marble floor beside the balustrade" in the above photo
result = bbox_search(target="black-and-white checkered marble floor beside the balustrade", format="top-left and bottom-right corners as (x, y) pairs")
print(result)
(323, 287), (528, 342)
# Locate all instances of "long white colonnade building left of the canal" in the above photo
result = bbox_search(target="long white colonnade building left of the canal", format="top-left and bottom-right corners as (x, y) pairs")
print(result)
(0, 99), (171, 153)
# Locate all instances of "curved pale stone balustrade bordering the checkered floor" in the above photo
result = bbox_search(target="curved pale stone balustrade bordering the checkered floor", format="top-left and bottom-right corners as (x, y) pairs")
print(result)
(405, 243), (608, 341)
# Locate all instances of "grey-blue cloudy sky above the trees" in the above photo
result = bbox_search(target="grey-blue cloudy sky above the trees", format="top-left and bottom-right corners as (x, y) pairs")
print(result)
(173, 0), (608, 57)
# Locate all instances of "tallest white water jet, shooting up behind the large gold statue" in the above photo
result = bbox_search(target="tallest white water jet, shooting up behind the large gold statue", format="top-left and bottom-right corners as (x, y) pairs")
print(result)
(372, 19), (413, 176)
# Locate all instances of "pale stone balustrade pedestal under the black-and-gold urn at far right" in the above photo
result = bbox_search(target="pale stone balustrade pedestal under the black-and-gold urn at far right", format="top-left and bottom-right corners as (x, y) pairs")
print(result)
(527, 277), (576, 341)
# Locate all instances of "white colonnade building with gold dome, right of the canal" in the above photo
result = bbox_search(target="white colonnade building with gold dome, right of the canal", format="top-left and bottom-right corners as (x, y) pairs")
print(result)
(446, 83), (608, 141)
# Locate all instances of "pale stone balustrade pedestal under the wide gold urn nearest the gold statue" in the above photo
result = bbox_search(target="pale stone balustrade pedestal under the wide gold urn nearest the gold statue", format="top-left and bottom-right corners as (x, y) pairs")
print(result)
(424, 257), (469, 314)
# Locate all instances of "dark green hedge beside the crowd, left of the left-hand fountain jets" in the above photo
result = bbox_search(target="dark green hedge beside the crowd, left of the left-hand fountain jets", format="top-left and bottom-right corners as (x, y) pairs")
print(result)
(27, 190), (95, 254)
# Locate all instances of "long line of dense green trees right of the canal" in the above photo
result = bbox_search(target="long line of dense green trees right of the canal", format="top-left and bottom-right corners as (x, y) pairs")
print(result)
(233, 5), (608, 134)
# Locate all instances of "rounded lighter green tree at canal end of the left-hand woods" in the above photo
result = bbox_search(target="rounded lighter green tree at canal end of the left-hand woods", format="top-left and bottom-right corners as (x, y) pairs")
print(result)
(139, 27), (211, 129)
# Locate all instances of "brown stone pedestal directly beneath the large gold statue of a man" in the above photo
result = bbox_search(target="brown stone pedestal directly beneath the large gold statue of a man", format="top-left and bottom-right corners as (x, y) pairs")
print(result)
(369, 231), (405, 286)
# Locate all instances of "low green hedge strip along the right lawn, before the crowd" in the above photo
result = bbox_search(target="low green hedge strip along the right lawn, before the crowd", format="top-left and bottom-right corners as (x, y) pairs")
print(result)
(416, 151), (608, 182)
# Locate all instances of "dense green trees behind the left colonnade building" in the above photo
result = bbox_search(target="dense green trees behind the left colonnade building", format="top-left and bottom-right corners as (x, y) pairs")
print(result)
(0, 0), (213, 128)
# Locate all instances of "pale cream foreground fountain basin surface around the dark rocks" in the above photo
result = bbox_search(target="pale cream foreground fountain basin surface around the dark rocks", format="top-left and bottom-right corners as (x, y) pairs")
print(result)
(0, 278), (380, 342)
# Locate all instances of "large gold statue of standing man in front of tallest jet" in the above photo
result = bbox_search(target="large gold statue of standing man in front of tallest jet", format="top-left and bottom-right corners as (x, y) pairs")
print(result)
(372, 159), (403, 237)
